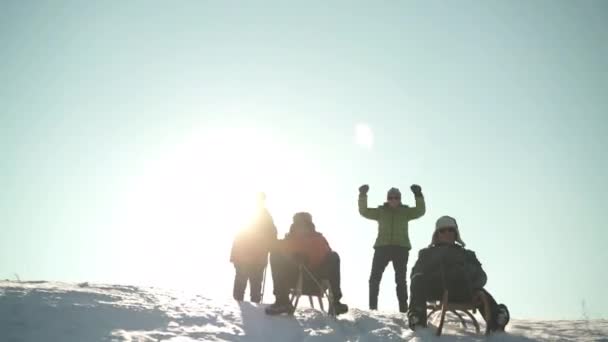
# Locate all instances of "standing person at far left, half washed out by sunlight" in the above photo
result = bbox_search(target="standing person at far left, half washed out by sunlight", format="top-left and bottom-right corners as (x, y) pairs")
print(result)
(230, 194), (277, 303)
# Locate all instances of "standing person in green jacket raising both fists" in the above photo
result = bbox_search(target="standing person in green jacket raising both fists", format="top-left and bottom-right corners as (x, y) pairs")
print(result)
(359, 184), (426, 312)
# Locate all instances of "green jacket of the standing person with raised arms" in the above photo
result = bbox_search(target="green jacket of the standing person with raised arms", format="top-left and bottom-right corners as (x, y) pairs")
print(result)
(359, 195), (426, 250)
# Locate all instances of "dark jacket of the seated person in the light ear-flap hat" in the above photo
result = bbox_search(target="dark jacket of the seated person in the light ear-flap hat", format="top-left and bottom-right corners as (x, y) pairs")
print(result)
(411, 244), (488, 290)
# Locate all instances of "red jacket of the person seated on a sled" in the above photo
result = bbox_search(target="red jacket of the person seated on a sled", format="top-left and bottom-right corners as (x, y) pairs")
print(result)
(279, 231), (331, 268)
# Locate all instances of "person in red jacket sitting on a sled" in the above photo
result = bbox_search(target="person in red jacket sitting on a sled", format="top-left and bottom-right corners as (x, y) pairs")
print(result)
(266, 212), (348, 315)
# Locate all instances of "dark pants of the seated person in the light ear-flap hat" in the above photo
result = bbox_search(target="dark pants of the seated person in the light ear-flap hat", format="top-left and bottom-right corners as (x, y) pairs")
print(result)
(410, 274), (498, 331)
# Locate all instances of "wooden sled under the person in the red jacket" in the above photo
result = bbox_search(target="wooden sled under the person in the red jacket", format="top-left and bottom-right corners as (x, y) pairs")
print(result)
(289, 265), (336, 317)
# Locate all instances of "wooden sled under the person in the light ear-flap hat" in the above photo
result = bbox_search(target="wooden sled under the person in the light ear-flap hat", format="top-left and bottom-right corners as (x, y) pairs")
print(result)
(427, 290), (490, 336)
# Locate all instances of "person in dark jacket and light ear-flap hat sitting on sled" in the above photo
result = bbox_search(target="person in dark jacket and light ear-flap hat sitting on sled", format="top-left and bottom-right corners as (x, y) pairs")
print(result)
(408, 216), (509, 332)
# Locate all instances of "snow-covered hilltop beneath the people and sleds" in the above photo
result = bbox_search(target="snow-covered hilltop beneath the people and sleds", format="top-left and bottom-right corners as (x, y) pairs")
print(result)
(0, 282), (608, 342)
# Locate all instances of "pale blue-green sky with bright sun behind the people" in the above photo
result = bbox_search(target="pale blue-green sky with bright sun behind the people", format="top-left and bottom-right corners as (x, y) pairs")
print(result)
(0, 0), (608, 319)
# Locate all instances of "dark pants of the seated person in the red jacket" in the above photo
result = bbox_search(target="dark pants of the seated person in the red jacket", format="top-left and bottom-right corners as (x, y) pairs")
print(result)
(270, 252), (342, 303)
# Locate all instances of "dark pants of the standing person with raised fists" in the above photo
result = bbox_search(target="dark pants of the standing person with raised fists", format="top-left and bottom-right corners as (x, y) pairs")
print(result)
(369, 246), (409, 312)
